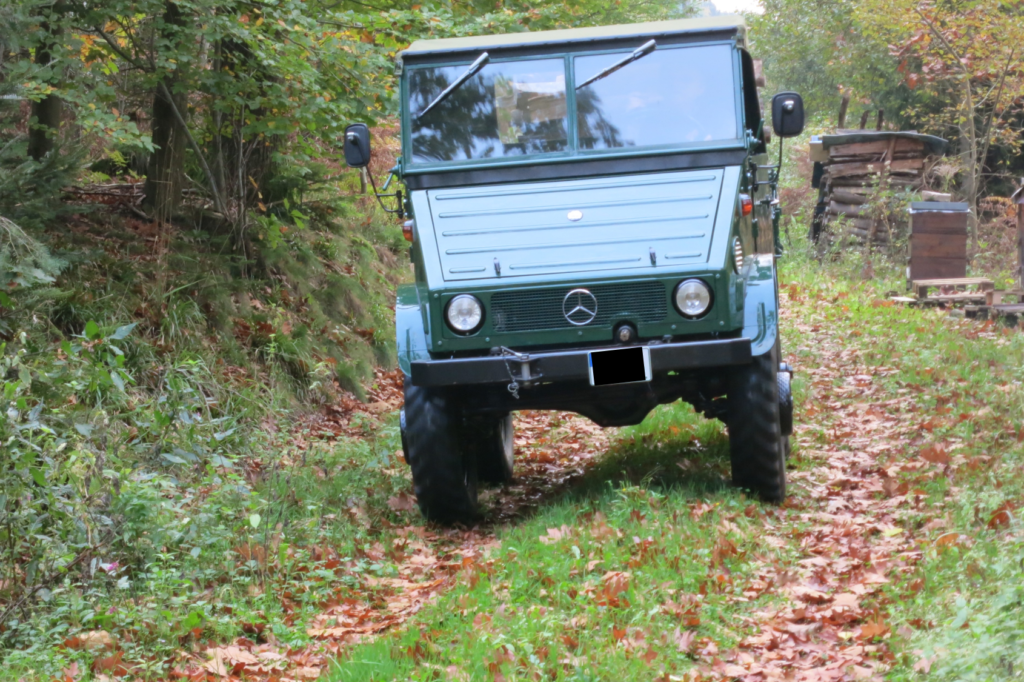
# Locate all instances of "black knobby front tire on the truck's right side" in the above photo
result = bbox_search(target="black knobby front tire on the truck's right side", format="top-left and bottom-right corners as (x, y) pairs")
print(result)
(728, 350), (785, 503)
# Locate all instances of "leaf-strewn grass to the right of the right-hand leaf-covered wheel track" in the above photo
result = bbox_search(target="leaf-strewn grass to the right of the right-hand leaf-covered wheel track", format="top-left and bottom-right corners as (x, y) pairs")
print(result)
(783, 242), (1024, 681)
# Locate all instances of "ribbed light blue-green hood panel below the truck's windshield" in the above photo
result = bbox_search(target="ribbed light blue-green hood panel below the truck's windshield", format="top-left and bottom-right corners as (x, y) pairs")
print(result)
(419, 168), (724, 282)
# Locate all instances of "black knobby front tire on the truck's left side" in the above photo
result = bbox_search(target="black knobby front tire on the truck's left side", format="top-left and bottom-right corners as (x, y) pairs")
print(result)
(404, 384), (477, 524)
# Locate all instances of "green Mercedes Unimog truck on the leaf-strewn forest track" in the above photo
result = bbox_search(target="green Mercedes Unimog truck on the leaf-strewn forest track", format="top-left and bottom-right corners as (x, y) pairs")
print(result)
(345, 17), (804, 523)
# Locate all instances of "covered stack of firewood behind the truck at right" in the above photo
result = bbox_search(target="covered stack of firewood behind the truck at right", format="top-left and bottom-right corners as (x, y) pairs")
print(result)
(811, 131), (948, 244)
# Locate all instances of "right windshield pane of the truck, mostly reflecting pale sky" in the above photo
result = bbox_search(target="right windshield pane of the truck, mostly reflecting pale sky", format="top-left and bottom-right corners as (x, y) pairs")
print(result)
(574, 45), (737, 150)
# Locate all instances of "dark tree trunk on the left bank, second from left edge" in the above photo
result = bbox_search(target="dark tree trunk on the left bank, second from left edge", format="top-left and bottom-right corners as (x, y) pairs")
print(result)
(143, 1), (187, 220)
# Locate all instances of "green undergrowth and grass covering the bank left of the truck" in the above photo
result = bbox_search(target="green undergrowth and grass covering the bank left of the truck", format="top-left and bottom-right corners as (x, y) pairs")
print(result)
(0, 180), (417, 679)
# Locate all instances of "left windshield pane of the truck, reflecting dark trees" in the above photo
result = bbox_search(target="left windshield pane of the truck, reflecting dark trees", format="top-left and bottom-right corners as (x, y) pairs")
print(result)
(409, 58), (568, 163)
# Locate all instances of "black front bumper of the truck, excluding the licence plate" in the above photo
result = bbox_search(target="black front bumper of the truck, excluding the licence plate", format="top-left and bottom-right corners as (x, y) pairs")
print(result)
(412, 338), (751, 386)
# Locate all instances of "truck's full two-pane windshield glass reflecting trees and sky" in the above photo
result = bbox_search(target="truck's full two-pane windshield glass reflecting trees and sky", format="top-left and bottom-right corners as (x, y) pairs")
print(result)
(407, 44), (739, 165)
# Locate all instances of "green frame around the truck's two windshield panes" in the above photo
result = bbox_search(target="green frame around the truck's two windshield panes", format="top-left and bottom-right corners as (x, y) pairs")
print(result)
(399, 38), (746, 174)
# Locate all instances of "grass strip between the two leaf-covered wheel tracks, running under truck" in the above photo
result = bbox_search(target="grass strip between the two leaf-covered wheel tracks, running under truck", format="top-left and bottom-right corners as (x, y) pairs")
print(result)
(331, 404), (806, 681)
